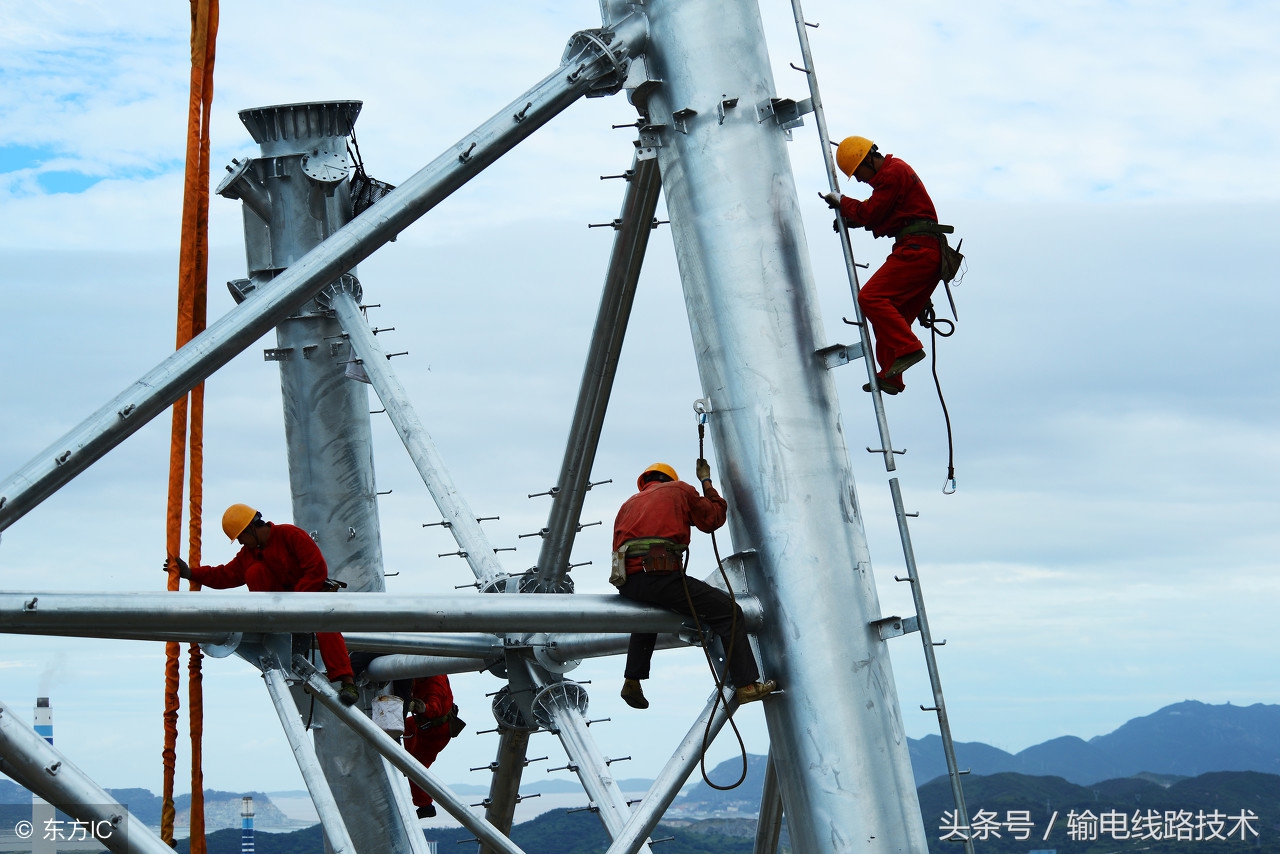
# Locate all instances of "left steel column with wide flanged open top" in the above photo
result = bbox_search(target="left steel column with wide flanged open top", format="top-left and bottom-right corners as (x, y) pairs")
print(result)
(227, 101), (417, 854)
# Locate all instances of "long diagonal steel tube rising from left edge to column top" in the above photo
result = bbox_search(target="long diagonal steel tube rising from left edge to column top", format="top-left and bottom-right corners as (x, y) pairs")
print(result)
(0, 15), (645, 531)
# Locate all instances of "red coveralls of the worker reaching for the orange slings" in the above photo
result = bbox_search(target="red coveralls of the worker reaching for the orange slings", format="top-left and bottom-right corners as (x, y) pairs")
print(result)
(191, 522), (352, 680)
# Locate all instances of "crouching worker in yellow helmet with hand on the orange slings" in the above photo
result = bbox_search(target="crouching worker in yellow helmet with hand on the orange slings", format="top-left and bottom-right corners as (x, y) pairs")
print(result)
(164, 504), (360, 705)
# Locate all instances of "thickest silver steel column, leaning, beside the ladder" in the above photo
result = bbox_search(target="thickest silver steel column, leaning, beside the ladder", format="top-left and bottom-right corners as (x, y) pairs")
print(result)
(640, 0), (927, 854)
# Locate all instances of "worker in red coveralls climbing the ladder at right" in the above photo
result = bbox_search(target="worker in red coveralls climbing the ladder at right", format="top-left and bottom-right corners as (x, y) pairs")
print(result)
(818, 137), (951, 394)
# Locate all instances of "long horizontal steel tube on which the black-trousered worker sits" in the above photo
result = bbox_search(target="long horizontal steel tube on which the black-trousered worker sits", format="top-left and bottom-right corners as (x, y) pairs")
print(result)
(0, 592), (760, 634)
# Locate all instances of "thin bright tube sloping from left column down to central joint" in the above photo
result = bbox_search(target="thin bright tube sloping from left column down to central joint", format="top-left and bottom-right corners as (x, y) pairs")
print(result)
(333, 293), (503, 588)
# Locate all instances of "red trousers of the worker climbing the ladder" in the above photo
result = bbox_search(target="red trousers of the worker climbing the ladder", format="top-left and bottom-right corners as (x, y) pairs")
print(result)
(858, 234), (942, 389)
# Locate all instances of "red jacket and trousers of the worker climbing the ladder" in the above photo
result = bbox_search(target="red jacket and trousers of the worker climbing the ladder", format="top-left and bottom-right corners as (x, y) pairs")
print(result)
(840, 154), (942, 389)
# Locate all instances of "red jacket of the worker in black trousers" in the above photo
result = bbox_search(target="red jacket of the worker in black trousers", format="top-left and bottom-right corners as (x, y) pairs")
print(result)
(613, 480), (728, 575)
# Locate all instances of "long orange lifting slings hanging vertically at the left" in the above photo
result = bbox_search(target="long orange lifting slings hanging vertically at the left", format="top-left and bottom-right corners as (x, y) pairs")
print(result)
(160, 0), (218, 854)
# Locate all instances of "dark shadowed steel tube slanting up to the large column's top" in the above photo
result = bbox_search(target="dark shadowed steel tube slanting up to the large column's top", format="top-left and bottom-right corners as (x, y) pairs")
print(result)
(535, 154), (662, 593)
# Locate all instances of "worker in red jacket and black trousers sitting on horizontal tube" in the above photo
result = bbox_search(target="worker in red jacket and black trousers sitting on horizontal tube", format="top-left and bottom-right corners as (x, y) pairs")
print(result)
(609, 460), (777, 709)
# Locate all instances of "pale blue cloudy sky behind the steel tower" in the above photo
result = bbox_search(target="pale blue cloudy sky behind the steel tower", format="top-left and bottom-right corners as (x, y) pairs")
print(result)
(0, 0), (1280, 814)
